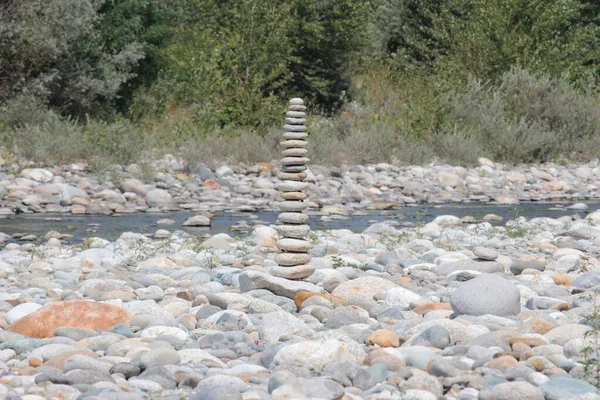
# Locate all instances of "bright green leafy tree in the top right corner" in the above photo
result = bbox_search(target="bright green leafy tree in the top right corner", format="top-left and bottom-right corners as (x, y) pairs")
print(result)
(448, 0), (600, 84)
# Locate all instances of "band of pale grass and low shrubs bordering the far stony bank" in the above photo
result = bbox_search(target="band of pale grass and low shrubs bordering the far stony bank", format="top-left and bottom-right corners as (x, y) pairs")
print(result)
(0, 69), (600, 169)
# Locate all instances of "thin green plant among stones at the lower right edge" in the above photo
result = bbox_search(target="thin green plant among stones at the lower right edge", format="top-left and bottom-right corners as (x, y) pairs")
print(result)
(579, 291), (600, 388)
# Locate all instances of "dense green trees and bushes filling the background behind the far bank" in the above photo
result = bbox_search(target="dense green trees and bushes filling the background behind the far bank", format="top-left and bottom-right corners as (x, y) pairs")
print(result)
(0, 0), (600, 162)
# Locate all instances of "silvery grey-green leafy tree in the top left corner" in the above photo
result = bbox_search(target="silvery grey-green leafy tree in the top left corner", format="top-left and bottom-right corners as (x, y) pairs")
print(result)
(0, 0), (143, 116)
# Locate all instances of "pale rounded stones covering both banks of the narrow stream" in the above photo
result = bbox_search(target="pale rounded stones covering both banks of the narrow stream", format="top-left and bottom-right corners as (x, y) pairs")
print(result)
(0, 156), (600, 400)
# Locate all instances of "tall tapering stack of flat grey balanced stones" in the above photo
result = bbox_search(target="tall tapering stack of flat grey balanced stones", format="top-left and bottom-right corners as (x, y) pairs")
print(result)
(270, 98), (315, 279)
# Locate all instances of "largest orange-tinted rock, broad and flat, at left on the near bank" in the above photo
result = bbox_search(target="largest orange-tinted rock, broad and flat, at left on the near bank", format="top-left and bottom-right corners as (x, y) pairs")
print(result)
(7, 300), (131, 338)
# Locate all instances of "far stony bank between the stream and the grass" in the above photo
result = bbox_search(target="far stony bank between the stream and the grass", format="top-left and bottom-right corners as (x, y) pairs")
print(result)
(0, 156), (600, 215)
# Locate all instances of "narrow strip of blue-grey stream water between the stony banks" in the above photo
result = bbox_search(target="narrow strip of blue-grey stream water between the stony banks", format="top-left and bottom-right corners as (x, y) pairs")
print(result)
(0, 201), (600, 242)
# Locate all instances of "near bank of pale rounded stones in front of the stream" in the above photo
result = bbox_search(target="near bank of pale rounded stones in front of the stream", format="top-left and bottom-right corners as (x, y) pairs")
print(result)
(0, 212), (600, 400)
